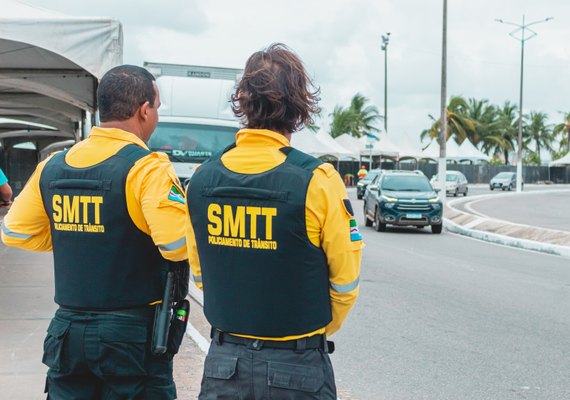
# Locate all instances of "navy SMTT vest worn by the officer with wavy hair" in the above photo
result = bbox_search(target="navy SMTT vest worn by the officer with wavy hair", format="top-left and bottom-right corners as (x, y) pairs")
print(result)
(187, 147), (332, 337)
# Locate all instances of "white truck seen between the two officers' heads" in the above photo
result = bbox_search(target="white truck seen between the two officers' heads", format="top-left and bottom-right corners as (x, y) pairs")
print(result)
(144, 62), (243, 182)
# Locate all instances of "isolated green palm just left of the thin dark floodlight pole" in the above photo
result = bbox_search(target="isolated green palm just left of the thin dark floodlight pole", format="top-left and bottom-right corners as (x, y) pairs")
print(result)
(330, 93), (382, 138)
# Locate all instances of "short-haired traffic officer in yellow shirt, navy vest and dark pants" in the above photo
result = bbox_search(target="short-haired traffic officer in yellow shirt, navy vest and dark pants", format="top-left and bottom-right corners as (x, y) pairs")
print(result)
(2, 65), (188, 400)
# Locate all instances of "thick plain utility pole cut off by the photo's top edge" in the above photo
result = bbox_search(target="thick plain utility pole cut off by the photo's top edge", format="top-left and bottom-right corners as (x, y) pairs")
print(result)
(437, 0), (447, 205)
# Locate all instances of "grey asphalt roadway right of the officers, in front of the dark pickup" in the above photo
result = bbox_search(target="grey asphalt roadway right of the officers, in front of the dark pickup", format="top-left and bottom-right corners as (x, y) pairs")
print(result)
(332, 191), (570, 400)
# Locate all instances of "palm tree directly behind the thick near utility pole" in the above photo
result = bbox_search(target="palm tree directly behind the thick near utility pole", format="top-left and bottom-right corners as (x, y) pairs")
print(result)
(421, 96), (475, 143)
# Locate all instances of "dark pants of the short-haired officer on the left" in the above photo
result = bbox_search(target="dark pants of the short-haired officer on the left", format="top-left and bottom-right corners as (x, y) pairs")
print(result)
(42, 309), (176, 400)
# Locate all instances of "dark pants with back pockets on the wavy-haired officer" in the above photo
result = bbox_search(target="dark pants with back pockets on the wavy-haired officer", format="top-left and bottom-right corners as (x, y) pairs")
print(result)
(199, 340), (337, 400)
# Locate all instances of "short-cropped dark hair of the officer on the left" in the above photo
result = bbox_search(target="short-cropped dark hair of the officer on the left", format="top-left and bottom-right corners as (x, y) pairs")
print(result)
(97, 65), (156, 122)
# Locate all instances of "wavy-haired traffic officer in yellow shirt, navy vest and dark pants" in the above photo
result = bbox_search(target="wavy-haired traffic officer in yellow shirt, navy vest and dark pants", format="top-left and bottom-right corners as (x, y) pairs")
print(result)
(186, 44), (362, 400)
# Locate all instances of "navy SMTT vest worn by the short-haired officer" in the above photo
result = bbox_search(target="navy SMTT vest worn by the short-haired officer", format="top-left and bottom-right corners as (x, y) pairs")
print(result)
(40, 144), (167, 310)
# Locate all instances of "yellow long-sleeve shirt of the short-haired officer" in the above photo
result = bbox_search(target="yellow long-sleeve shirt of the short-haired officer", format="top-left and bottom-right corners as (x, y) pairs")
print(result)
(2, 127), (187, 261)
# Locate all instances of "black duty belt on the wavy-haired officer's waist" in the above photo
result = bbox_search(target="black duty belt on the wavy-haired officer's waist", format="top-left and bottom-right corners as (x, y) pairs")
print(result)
(210, 328), (334, 354)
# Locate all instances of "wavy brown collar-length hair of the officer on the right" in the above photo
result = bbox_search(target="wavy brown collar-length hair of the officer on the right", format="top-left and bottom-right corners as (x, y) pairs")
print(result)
(231, 43), (320, 133)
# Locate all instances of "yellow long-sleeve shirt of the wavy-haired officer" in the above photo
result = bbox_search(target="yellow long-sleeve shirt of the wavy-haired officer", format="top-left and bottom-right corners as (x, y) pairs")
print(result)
(186, 129), (362, 340)
